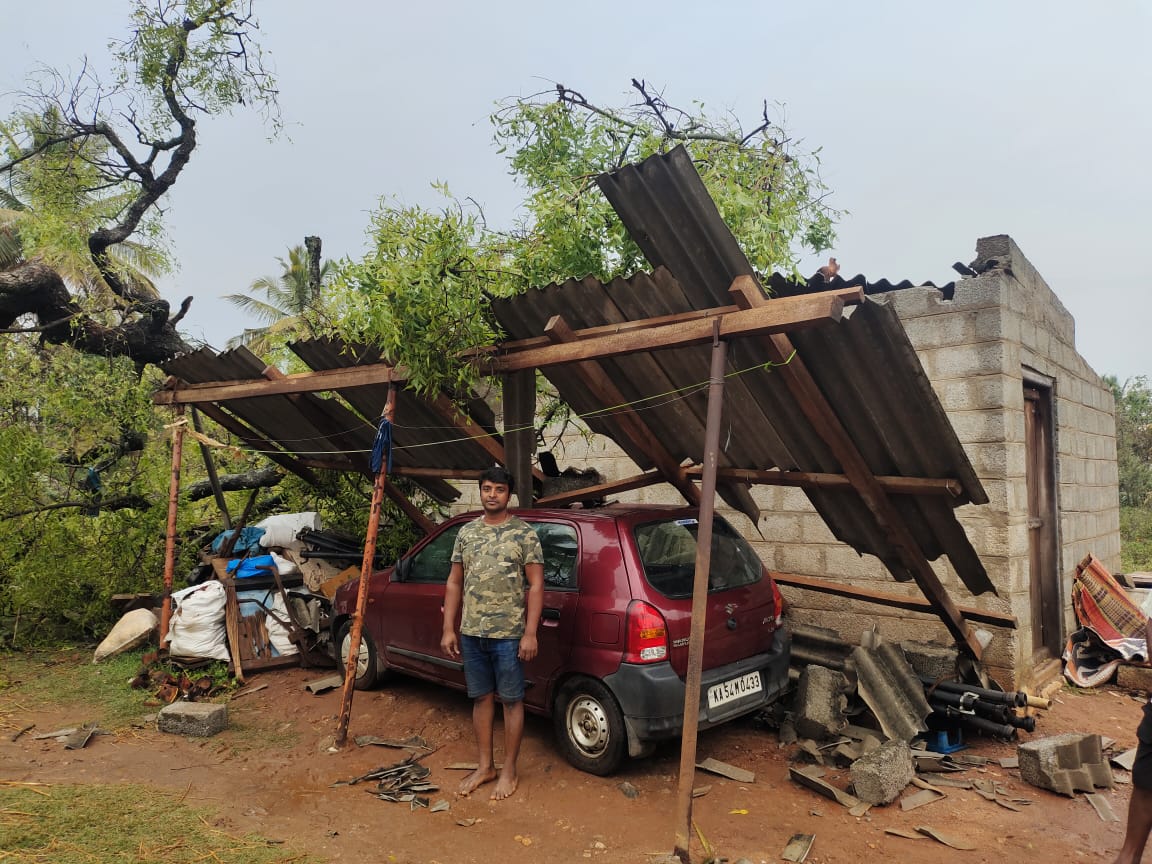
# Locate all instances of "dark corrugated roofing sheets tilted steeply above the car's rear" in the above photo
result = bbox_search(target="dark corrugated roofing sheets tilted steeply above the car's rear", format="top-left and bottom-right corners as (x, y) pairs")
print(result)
(494, 149), (994, 594)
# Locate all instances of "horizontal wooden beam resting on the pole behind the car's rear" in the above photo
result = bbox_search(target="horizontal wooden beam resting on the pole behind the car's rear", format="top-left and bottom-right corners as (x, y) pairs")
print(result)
(487, 288), (864, 372)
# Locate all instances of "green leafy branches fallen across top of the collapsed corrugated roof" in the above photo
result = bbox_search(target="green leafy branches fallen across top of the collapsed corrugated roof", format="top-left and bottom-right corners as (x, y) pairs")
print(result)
(331, 83), (839, 393)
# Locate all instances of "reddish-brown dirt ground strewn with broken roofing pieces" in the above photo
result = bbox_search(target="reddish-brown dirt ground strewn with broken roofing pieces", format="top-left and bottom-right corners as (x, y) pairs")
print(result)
(0, 669), (1140, 864)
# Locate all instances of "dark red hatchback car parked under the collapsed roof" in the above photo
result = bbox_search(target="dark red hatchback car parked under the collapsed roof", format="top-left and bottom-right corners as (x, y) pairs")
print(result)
(332, 505), (790, 774)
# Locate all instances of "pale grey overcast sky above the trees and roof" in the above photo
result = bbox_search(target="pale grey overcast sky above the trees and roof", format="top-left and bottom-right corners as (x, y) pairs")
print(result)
(0, 0), (1152, 380)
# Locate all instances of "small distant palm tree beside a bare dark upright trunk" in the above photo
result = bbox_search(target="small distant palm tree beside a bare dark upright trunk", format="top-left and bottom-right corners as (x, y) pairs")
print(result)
(223, 245), (333, 355)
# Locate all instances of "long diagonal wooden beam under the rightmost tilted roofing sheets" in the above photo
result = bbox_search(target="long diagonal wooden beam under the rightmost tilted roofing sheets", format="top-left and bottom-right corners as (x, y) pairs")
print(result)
(729, 276), (983, 660)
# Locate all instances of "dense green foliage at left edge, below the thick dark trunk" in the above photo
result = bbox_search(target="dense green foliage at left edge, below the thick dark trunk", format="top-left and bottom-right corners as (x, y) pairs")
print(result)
(0, 339), (214, 644)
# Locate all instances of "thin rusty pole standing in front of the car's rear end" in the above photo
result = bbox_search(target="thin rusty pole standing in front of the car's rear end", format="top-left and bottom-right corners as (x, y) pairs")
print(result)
(673, 318), (728, 864)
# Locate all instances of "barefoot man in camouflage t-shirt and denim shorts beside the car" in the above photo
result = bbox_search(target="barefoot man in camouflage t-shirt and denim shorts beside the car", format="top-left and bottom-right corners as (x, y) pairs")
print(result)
(440, 465), (544, 801)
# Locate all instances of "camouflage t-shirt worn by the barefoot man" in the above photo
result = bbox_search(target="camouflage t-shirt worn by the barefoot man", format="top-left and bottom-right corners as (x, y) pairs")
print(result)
(452, 516), (544, 639)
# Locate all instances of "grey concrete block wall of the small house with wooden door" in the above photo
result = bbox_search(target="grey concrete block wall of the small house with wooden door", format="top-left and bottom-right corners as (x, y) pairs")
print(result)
(461, 235), (1120, 687)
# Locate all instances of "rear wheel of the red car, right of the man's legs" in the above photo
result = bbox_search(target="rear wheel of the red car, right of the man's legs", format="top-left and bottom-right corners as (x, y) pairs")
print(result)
(553, 677), (628, 776)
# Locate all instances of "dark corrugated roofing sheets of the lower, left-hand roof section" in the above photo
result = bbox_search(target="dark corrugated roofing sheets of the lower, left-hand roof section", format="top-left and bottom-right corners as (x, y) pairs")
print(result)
(164, 340), (500, 501)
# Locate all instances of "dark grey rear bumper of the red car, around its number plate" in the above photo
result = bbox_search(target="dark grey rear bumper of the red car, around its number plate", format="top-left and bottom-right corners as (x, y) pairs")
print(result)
(604, 627), (791, 742)
